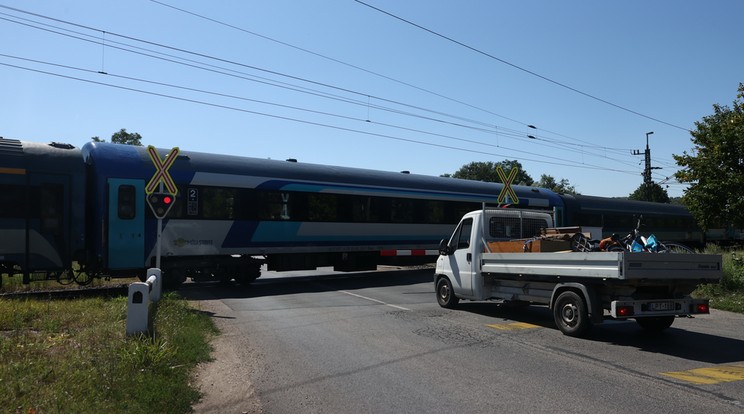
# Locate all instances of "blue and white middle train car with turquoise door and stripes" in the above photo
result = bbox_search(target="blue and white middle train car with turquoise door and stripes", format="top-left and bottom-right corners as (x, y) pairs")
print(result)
(82, 143), (561, 281)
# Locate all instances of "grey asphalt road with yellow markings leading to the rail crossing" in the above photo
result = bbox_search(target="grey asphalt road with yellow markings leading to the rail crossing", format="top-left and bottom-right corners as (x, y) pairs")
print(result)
(184, 270), (744, 413)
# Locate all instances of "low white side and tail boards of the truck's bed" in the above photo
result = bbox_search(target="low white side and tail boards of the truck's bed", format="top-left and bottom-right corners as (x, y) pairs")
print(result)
(480, 252), (722, 282)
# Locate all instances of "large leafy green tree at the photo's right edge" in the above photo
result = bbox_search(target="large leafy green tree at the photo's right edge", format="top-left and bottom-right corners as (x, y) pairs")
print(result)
(674, 83), (744, 229)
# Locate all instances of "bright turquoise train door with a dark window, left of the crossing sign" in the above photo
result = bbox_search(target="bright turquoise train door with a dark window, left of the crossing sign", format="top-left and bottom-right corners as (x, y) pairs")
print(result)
(108, 178), (145, 270)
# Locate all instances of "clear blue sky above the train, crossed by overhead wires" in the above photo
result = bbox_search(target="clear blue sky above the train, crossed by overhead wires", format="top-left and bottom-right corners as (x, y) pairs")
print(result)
(0, 0), (744, 196)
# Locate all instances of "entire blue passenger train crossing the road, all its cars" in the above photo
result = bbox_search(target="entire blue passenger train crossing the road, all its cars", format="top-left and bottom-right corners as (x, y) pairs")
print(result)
(0, 138), (716, 285)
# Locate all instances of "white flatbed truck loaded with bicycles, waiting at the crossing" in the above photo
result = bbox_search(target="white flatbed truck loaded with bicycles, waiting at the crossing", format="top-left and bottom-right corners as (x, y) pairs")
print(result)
(434, 208), (722, 336)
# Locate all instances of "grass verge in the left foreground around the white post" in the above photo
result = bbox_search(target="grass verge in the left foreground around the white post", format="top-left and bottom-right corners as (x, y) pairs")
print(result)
(0, 293), (217, 413)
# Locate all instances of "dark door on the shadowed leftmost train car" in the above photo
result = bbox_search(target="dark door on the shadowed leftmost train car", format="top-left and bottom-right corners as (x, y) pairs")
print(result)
(24, 173), (72, 271)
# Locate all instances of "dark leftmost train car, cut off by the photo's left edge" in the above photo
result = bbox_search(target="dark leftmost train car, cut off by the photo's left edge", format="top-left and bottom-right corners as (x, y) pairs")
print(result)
(0, 138), (85, 283)
